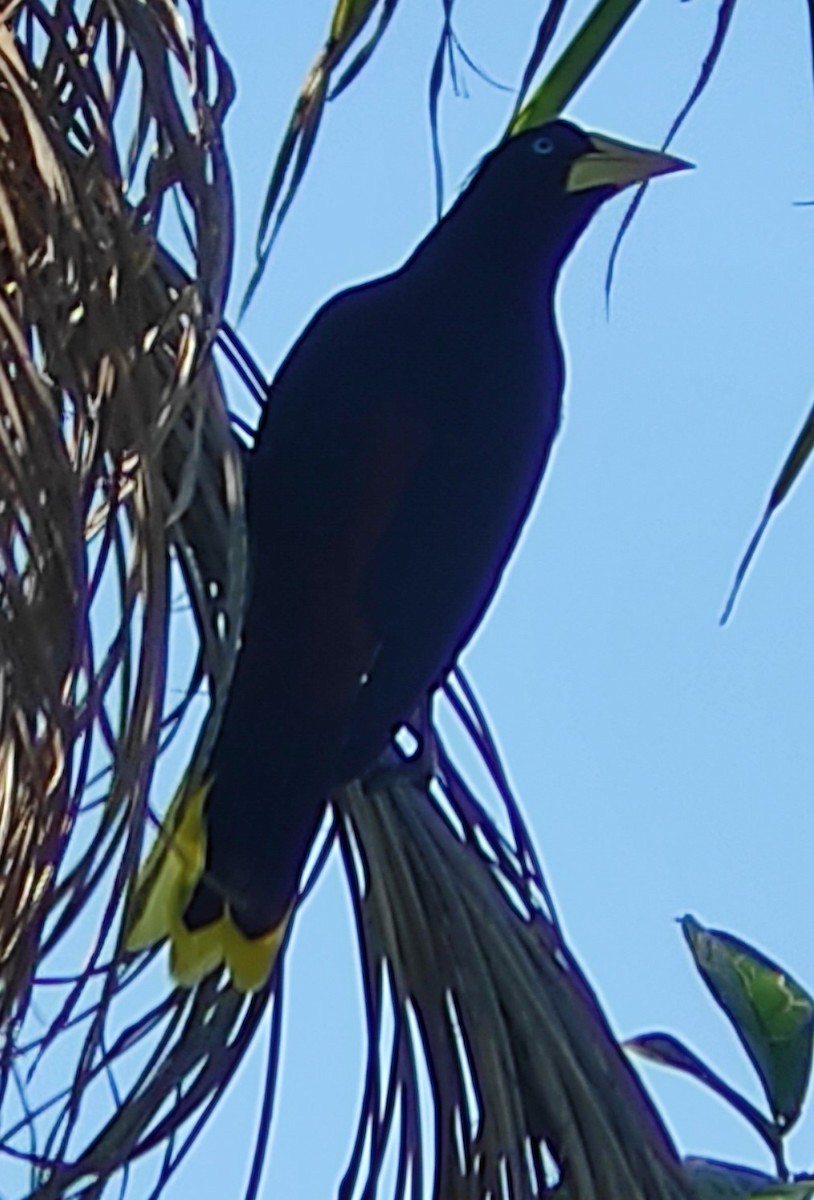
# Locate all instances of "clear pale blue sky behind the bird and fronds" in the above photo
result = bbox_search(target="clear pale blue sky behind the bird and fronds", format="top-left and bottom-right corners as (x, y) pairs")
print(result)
(162, 0), (814, 1200)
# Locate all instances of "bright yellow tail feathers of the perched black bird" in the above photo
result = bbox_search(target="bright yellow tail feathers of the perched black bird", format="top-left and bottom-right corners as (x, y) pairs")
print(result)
(125, 782), (289, 991)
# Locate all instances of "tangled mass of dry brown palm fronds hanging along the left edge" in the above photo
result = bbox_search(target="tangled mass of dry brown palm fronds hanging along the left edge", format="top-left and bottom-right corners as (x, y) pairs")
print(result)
(0, 0), (262, 1195)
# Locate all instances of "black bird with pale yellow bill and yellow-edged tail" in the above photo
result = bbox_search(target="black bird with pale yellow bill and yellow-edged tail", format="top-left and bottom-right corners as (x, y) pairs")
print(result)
(128, 119), (688, 991)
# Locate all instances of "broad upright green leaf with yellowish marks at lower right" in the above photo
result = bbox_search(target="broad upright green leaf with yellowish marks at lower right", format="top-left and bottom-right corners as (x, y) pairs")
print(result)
(681, 916), (814, 1130)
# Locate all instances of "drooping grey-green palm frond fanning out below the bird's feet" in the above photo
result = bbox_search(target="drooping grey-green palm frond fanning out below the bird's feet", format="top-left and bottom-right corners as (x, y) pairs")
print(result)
(340, 676), (690, 1200)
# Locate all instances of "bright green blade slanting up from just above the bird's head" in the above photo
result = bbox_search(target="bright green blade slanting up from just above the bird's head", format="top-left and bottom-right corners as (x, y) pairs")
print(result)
(509, 0), (641, 133)
